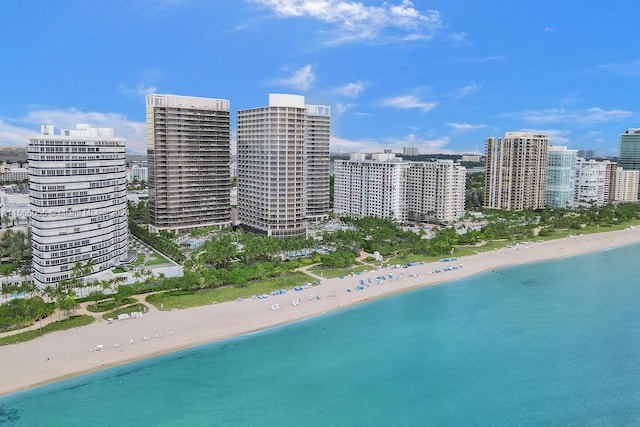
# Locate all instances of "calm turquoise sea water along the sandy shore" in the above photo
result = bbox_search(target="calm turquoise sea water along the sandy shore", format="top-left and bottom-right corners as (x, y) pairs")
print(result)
(0, 245), (640, 426)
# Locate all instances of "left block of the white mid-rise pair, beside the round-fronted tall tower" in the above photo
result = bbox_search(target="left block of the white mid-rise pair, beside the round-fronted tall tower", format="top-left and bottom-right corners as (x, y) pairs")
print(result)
(333, 153), (408, 222)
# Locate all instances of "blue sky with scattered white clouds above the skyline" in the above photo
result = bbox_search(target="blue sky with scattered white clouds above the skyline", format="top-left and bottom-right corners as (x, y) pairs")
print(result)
(0, 0), (640, 155)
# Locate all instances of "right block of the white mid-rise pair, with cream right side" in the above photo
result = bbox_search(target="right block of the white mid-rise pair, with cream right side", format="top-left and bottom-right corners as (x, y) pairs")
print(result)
(406, 160), (467, 223)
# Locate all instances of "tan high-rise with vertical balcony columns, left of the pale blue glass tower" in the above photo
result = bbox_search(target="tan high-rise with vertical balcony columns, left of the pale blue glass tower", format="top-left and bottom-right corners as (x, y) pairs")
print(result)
(484, 132), (549, 210)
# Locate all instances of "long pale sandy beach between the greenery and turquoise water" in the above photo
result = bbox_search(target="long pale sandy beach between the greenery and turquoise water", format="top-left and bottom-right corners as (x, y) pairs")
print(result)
(0, 228), (640, 395)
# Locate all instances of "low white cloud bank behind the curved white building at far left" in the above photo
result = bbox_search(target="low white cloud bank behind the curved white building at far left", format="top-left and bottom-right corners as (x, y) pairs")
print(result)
(0, 108), (147, 154)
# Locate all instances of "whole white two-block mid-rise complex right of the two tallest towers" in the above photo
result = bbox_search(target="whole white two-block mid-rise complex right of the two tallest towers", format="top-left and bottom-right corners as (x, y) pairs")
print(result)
(334, 153), (466, 226)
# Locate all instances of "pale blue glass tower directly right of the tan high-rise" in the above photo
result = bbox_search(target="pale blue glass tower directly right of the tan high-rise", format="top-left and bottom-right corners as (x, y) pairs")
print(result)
(546, 145), (578, 208)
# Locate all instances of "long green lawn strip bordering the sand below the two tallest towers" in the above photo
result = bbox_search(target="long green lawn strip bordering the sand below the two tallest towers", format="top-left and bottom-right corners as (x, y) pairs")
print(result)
(147, 272), (315, 310)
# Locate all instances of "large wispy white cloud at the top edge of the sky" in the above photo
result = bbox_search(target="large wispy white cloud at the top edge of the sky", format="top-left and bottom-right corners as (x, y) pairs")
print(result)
(249, 0), (444, 44)
